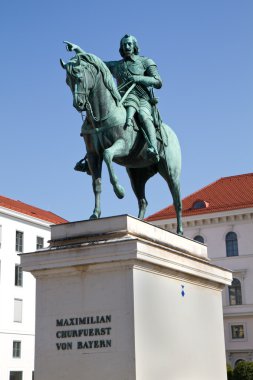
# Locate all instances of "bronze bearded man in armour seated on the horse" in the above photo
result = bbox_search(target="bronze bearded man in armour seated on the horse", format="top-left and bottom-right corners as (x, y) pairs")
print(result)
(105, 34), (162, 161)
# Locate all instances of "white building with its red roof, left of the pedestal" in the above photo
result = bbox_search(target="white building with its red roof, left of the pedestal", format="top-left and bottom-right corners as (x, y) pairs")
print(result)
(0, 196), (66, 380)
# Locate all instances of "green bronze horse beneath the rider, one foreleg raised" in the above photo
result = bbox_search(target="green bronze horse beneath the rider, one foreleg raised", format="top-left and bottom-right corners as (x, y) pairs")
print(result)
(60, 44), (183, 235)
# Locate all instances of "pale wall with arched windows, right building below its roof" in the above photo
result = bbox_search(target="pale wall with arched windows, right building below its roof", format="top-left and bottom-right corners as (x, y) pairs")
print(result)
(154, 209), (253, 365)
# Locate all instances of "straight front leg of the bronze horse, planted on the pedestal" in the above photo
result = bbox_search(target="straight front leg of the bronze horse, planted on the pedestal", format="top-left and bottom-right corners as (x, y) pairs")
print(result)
(87, 153), (102, 219)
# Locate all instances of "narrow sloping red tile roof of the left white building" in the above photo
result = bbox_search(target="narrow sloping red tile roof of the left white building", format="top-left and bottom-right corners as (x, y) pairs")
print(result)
(0, 195), (67, 224)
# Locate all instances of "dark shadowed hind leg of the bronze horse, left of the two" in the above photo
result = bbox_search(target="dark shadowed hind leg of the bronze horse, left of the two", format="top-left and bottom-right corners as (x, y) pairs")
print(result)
(127, 167), (155, 219)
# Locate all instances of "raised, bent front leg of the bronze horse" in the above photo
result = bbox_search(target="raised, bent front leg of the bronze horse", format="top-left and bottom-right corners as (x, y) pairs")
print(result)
(104, 139), (129, 199)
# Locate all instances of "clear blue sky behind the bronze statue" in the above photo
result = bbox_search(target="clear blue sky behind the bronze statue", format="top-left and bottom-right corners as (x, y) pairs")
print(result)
(0, 0), (253, 221)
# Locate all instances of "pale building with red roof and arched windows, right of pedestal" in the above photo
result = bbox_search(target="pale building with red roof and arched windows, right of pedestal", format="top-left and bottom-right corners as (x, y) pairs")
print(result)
(147, 173), (253, 366)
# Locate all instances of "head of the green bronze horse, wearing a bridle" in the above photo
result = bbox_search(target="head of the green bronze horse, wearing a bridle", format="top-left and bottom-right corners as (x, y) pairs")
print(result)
(60, 55), (95, 112)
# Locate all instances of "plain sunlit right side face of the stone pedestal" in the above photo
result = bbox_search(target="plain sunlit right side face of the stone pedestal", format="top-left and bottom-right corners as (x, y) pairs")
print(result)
(134, 269), (226, 380)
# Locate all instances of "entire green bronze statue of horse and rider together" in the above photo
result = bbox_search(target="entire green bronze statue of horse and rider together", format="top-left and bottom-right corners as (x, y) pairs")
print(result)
(61, 35), (183, 234)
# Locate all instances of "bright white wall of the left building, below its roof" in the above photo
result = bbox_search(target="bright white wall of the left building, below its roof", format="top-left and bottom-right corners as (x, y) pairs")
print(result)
(0, 208), (50, 380)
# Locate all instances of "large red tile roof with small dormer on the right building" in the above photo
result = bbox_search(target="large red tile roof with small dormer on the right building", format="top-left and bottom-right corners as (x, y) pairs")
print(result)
(146, 173), (253, 221)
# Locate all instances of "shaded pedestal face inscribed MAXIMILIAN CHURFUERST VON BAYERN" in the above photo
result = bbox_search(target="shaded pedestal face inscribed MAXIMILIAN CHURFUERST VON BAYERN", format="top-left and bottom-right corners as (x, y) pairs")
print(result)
(35, 264), (135, 380)
